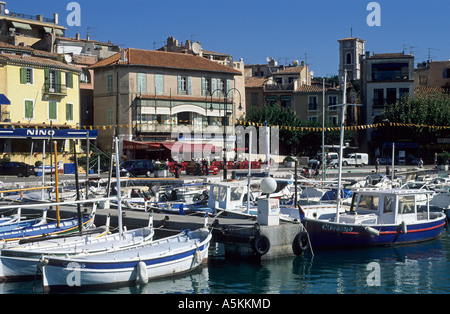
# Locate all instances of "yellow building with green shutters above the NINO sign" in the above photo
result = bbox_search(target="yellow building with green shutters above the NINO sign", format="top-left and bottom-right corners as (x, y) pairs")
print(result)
(0, 43), (81, 159)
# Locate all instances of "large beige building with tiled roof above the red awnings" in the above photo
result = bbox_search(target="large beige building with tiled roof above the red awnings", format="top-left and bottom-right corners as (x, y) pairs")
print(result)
(91, 48), (245, 159)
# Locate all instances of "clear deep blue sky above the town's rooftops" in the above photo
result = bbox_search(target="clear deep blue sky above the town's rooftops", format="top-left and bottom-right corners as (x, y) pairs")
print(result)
(6, 0), (450, 77)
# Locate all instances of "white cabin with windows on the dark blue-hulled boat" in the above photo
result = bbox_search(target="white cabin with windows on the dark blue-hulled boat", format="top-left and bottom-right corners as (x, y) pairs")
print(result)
(340, 189), (438, 224)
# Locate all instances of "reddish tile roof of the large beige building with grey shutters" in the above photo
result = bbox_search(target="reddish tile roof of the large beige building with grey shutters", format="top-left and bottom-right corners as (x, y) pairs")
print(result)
(91, 48), (242, 75)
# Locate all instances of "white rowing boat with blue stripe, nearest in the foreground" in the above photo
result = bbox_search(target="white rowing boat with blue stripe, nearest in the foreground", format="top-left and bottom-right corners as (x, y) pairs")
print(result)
(42, 228), (212, 292)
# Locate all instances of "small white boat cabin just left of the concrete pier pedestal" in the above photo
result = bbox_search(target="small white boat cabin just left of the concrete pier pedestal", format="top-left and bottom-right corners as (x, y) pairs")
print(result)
(208, 182), (248, 210)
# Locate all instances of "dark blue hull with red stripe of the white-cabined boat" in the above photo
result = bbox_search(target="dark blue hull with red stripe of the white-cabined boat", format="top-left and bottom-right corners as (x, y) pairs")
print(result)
(303, 215), (446, 249)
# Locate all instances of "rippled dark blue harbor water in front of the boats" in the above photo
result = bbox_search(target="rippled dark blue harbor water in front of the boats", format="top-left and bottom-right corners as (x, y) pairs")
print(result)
(0, 230), (450, 295)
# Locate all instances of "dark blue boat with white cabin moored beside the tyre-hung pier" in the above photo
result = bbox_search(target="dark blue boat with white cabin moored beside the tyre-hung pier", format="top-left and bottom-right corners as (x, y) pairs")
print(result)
(300, 189), (446, 249)
